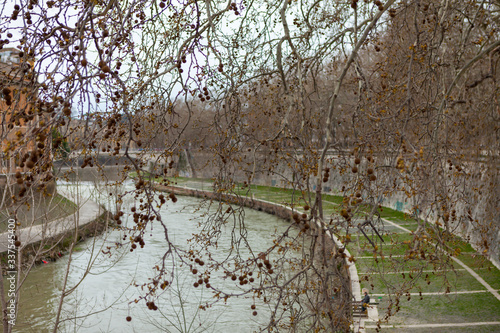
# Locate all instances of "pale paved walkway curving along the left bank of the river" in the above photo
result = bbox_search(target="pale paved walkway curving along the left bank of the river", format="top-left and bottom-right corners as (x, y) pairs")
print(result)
(0, 191), (104, 253)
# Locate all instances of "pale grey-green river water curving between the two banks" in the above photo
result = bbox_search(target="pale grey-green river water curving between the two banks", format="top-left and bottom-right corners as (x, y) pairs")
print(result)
(14, 183), (289, 333)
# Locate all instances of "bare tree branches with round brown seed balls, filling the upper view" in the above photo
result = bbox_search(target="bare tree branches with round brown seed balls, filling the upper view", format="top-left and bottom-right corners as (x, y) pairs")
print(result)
(0, 0), (500, 332)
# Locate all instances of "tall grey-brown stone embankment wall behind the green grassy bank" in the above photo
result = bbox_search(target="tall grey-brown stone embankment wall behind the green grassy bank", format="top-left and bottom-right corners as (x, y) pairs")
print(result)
(150, 150), (500, 269)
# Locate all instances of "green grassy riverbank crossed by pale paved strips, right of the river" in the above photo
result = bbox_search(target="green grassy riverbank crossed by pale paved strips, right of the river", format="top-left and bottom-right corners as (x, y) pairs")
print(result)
(151, 178), (500, 333)
